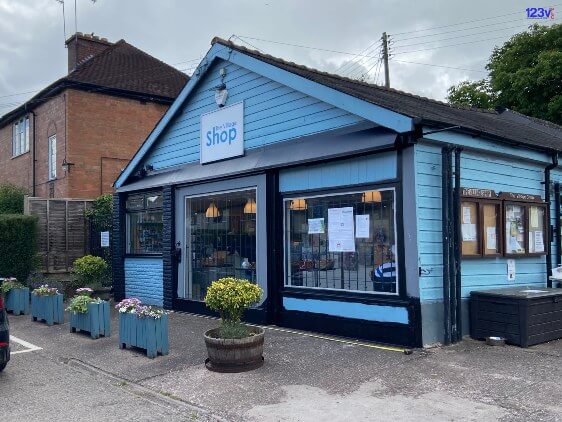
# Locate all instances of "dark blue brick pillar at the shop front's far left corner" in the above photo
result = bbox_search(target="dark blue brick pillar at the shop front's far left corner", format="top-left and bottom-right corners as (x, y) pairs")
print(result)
(111, 193), (125, 301)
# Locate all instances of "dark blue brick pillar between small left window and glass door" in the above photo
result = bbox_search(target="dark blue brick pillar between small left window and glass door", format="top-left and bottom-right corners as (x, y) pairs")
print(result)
(162, 186), (177, 309)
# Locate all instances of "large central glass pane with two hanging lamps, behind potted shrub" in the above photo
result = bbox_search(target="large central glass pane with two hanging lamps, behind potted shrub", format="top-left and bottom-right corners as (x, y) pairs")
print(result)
(186, 189), (257, 300)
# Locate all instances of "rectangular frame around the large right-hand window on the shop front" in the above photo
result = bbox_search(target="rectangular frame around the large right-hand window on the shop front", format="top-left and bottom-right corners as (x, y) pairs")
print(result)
(281, 182), (398, 300)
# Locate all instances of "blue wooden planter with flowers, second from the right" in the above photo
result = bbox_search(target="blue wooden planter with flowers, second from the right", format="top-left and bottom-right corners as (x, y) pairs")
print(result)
(66, 287), (111, 339)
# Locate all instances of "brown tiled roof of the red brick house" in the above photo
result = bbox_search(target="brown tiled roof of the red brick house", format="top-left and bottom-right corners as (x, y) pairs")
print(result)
(0, 40), (189, 127)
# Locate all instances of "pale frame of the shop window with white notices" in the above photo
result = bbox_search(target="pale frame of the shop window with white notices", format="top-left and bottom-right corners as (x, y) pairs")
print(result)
(283, 186), (402, 297)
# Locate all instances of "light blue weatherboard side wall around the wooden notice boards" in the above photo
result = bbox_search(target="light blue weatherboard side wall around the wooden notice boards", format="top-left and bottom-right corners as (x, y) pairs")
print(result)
(415, 137), (546, 302)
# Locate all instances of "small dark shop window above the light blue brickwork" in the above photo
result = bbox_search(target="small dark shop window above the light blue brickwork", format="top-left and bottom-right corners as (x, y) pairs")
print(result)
(125, 192), (164, 255)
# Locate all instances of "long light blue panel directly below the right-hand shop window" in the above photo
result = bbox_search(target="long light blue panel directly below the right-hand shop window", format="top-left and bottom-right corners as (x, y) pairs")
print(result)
(283, 297), (409, 324)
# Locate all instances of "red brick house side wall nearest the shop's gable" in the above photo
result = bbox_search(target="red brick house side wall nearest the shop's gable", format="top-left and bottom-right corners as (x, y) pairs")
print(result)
(67, 90), (168, 198)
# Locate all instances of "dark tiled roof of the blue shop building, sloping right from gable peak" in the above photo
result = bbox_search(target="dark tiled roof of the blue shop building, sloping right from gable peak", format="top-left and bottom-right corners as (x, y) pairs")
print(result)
(212, 37), (562, 151)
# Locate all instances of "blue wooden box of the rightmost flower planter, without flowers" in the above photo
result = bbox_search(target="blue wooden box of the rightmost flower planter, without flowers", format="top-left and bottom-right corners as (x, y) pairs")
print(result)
(119, 313), (169, 358)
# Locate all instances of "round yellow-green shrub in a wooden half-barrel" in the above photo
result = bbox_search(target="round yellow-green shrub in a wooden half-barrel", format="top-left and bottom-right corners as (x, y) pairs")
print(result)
(205, 277), (265, 372)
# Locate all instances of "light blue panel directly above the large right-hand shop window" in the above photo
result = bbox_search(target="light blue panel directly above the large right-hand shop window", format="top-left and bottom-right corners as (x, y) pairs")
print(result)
(279, 151), (396, 192)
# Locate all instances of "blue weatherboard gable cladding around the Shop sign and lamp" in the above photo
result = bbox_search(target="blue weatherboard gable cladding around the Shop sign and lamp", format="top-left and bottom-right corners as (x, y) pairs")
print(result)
(143, 60), (364, 169)
